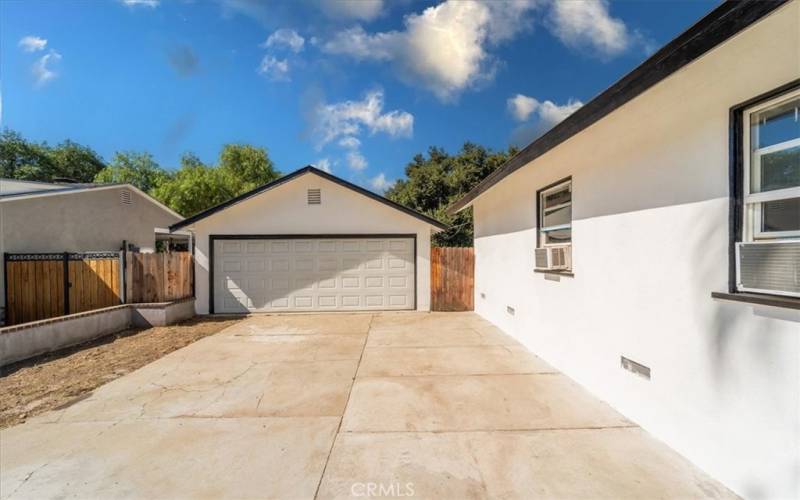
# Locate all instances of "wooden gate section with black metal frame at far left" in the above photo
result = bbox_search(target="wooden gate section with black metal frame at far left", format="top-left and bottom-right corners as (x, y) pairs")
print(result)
(4, 252), (122, 325)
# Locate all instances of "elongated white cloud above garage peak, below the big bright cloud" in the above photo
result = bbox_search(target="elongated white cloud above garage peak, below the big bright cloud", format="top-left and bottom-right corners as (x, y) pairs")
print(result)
(313, 90), (414, 148)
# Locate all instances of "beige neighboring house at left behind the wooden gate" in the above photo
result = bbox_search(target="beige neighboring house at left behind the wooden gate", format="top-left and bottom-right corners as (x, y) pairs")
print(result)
(0, 184), (182, 317)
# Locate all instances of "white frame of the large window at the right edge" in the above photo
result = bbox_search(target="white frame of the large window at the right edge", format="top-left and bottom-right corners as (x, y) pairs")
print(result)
(740, 87), (800, 242)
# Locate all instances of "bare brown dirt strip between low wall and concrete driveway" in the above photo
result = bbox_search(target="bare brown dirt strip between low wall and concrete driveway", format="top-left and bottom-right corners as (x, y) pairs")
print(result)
(0, 317), (244, 428)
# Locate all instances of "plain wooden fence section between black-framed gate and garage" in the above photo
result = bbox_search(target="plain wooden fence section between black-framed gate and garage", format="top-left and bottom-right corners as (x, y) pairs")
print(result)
(126, 252), (193, 303)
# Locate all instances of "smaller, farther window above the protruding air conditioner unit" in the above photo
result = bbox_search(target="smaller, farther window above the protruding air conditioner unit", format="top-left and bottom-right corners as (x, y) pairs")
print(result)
(538, 179), (572, 247)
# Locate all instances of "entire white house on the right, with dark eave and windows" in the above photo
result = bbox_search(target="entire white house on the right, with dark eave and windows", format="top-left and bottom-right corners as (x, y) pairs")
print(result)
(450, 0), (800, 498)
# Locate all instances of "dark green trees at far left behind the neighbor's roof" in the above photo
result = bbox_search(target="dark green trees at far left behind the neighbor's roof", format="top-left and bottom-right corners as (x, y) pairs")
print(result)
(0, 129), (105, 182)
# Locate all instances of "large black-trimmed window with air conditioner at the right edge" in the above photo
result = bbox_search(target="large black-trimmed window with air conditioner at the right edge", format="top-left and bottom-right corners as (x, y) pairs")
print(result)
(728, 81), (800, 300)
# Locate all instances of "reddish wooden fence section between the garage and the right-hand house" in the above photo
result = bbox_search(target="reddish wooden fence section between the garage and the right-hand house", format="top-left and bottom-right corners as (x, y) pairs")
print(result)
(431, 247), (475, 311)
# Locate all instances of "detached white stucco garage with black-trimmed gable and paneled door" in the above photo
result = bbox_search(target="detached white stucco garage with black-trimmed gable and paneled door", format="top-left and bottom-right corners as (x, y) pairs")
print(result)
(171, 167), (445, 314)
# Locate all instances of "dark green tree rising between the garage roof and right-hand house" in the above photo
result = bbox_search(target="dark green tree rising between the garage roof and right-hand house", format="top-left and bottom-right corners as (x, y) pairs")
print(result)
(385, 142), (516, 247)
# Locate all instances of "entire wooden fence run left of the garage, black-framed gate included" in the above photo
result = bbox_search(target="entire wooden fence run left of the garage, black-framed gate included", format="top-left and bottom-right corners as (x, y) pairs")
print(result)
(4, 252), (194, 325)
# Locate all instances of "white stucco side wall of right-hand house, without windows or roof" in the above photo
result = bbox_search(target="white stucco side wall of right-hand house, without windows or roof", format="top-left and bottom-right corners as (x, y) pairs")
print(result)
(474, 1), (800, 498)
